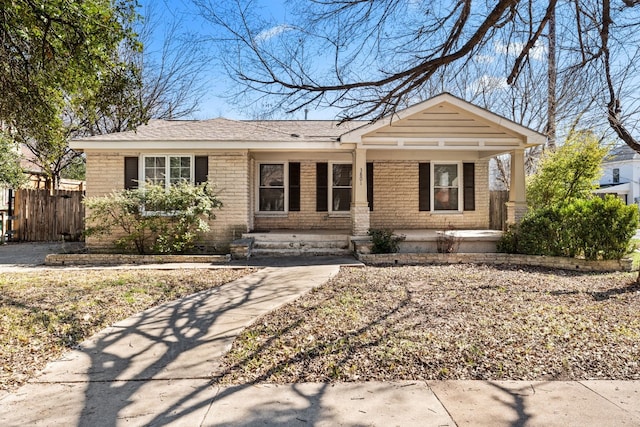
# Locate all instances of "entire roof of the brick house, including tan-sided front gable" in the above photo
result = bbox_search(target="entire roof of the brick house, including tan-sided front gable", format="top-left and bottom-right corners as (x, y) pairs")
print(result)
(70, 93), (546, 156)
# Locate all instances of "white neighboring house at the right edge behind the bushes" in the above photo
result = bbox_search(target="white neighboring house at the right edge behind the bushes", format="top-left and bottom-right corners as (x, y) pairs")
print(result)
(595, 144), (640, 205)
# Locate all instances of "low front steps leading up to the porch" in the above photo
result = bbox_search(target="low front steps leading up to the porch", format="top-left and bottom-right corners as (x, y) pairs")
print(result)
(239, 230), (352, 258)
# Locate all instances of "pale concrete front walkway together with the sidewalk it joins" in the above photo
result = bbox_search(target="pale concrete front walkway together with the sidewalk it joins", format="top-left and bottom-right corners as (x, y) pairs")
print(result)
(0, 261), (640, 426)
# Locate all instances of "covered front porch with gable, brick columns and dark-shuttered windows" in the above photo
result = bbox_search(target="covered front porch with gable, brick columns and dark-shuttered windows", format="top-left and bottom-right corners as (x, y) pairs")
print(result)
(248, 94), (544, 241)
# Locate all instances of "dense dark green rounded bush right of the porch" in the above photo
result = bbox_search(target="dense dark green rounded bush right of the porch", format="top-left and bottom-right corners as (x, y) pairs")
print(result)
(498, 196), (638, 260)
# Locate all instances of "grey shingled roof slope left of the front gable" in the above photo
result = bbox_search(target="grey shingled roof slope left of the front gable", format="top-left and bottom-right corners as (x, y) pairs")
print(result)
(74, 118), (366, 142)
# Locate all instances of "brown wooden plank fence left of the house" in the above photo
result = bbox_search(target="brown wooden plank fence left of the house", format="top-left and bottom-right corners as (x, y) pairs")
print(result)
(11, 189), (84, 242)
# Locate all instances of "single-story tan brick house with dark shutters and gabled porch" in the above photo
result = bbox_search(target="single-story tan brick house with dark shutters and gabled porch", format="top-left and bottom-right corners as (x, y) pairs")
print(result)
(71, 93), (545, 254)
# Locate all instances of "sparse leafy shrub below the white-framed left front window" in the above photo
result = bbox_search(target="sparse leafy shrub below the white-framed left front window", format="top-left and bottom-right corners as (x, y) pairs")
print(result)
(84, 182), (222, 254)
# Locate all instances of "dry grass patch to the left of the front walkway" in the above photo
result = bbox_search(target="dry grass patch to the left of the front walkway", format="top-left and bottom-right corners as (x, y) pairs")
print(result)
(0, 269), (251, 390)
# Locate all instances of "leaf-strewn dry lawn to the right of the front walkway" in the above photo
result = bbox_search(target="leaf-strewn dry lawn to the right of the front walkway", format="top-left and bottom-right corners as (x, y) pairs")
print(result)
(219, 265), (640, 384)
